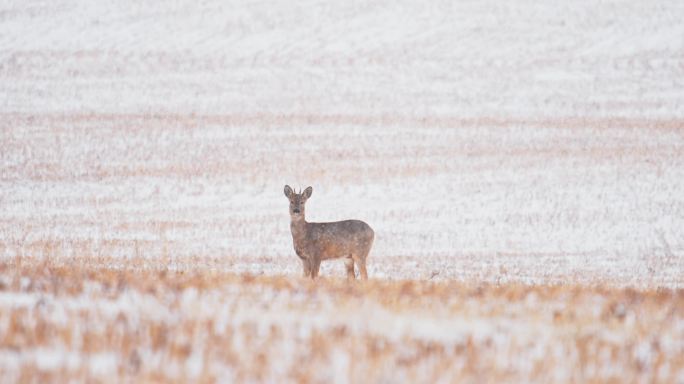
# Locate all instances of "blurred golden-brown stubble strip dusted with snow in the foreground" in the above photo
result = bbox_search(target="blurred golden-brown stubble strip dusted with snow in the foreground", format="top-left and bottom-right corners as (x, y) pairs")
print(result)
(0, 258), (684, 382)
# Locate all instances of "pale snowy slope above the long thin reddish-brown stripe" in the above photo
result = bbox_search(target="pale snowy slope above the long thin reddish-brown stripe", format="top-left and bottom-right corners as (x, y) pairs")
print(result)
(0, 0), (684, 119)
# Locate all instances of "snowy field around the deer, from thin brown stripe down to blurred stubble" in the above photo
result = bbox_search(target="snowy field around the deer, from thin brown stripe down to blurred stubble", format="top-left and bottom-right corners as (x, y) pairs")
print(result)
(0, 115), (684, 287)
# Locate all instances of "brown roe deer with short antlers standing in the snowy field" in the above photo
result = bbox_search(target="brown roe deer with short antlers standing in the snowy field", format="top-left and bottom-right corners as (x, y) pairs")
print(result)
(285, 185), (375, 280)
